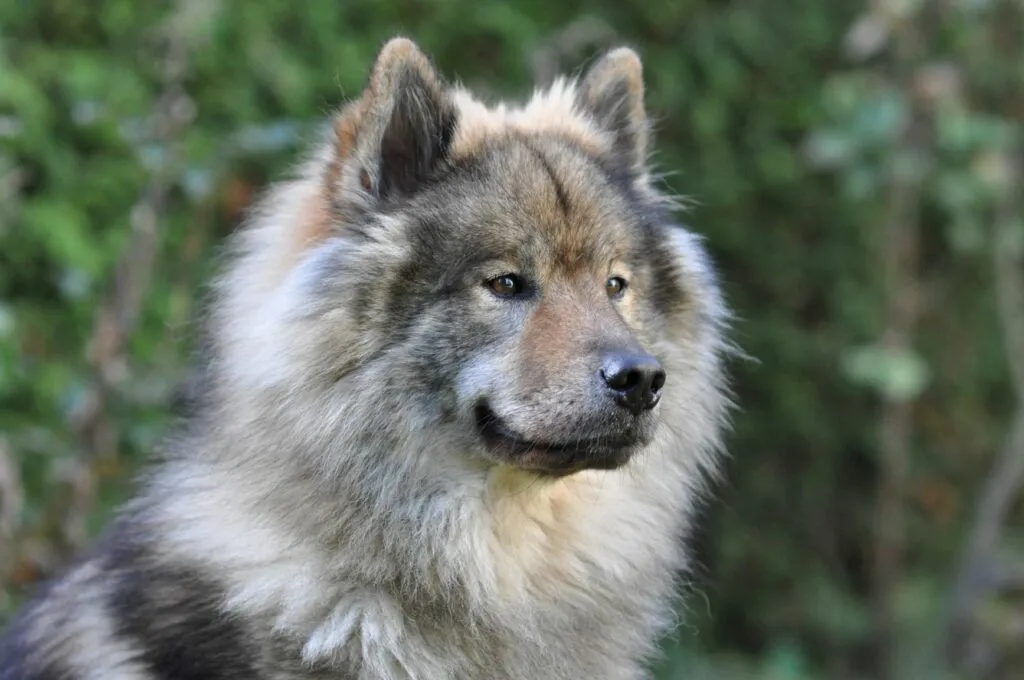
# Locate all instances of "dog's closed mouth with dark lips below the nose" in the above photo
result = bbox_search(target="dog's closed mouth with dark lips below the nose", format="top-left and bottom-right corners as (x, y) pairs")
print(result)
(474, 403), (641, 476)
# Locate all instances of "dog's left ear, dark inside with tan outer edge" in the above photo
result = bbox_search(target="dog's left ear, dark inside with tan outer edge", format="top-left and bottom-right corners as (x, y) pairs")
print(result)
(334, 38), (456, 202)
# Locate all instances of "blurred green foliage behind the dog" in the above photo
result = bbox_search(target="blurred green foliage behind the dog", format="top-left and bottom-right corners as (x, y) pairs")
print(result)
(0, 0), (1024, 680)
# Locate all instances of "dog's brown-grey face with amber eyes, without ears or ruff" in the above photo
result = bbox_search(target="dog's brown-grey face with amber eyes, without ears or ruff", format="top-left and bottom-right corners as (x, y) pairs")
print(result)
(372, 134), (671, 473)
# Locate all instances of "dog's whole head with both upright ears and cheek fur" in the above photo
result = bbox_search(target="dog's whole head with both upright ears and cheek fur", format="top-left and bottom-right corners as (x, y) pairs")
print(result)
(216, 39), (721, 475)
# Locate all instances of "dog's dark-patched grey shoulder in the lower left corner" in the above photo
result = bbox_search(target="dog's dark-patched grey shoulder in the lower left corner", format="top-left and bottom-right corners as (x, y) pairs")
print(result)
(0, 521), (268, 680)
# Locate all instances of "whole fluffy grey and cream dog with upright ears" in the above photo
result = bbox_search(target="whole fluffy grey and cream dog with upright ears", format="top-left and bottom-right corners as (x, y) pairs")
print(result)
(0, 37), (731, 680)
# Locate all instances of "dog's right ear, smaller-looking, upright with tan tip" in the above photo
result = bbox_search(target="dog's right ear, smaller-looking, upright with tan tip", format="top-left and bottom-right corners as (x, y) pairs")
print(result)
(577, 47), (648, 170)
